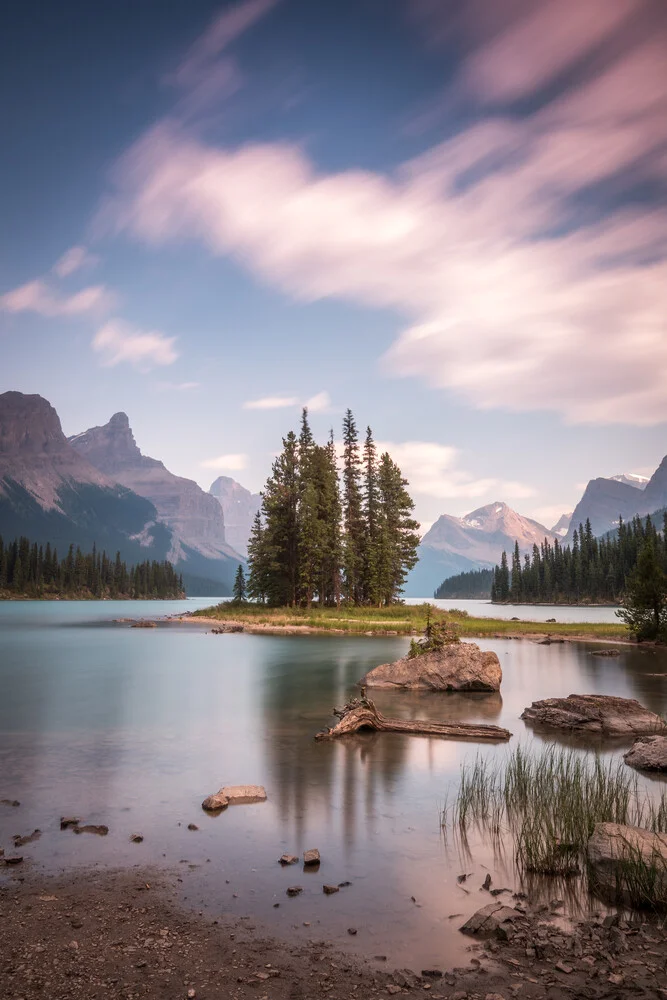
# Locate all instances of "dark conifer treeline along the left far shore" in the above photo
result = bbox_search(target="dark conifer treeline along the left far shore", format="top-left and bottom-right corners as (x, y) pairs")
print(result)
(0, 536), (185, 599)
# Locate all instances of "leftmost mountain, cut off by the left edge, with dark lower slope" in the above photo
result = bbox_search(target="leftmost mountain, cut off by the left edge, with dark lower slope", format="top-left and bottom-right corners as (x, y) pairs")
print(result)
(0, 392), (171, 562)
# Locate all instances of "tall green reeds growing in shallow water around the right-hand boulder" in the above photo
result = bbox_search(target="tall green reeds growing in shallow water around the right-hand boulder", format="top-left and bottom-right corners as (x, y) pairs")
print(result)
(442, 746), (667, 909)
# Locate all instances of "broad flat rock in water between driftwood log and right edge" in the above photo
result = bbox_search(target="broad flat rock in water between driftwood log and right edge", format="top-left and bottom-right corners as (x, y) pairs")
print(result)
(521, 694), (667, 736)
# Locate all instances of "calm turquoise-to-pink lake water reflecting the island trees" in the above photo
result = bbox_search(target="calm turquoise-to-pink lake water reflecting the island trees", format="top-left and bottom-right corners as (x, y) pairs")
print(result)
(0, 598), (667, 968)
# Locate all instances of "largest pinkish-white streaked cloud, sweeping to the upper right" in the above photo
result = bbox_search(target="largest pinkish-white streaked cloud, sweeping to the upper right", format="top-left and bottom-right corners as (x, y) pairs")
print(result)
(106, 0), (667, 425)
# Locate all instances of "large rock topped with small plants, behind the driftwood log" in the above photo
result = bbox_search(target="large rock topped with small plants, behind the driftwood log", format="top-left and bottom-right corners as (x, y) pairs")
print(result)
(359, 642), (503, 691)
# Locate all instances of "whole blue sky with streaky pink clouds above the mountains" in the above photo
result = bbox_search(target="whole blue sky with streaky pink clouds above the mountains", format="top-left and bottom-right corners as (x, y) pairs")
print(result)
(0, 0), (667, 527)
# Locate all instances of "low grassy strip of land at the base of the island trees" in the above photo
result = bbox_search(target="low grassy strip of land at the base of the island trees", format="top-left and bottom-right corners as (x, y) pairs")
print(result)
(184, 602), (629, 642)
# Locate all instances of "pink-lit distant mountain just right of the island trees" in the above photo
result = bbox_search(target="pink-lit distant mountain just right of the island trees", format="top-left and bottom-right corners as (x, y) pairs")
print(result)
(405, 502), (555, 597)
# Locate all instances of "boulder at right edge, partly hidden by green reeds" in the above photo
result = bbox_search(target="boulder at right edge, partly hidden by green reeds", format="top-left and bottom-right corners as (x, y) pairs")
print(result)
(587, 823), (667, 903)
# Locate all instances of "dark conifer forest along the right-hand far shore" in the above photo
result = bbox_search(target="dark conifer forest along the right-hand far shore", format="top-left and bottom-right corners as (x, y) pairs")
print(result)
(491, 512), (667, 604)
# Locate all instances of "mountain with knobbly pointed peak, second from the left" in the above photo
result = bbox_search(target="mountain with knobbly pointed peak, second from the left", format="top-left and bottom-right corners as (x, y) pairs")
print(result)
(69, 413), (241, 586)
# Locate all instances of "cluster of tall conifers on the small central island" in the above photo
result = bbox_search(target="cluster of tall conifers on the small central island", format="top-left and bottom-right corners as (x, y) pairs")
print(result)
(247, 410), (419, 607)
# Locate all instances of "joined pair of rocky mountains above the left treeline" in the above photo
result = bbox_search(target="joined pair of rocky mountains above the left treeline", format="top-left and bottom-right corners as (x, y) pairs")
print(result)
(0, 392), (242, 596)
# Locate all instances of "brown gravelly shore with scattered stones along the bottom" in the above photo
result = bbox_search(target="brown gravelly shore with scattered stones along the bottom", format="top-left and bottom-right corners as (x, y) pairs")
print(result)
(0, 869), (667, 1000)
